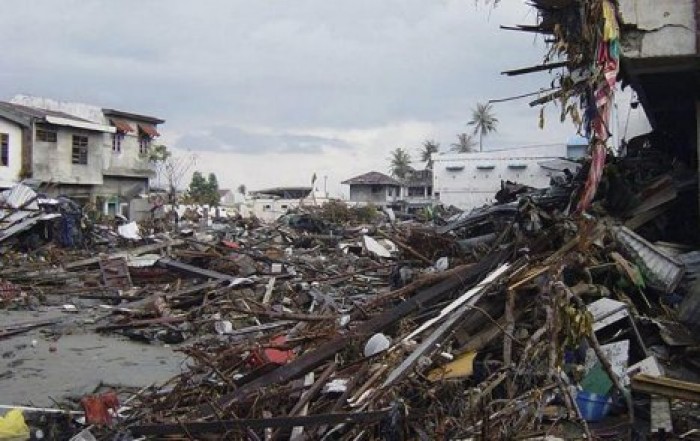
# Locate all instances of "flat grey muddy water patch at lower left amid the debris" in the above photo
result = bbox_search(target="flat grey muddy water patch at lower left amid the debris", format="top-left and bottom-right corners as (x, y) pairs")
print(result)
(0, 310), (184, 406)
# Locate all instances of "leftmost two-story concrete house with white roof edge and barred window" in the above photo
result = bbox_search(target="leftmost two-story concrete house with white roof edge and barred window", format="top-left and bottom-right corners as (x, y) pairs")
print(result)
(0, 102), (115, 201)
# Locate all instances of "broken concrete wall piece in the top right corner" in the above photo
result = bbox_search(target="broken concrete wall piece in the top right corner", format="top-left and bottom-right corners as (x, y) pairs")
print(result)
(619, 0), (697, 58)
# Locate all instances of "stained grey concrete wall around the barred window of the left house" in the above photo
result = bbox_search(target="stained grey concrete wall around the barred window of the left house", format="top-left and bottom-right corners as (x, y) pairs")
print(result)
(32, 127), (104, 185)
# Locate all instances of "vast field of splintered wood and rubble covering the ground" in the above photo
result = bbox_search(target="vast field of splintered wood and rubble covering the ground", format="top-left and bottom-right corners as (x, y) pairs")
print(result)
(0, 129), (700, 439)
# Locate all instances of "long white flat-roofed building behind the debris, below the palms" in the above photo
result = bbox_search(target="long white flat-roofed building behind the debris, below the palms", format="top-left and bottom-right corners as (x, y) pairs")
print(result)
(433, 140), (586, 210)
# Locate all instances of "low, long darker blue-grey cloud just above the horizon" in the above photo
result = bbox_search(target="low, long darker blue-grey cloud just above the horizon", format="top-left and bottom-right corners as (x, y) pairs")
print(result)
(175, 126), (351, 154)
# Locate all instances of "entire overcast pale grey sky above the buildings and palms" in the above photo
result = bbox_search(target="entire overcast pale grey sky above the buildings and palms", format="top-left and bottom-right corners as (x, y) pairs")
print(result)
(0, 0), (652, 194)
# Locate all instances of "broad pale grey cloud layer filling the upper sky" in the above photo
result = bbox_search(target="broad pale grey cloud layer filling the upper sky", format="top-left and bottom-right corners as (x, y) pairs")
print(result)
(0, 0), (560, 131)
